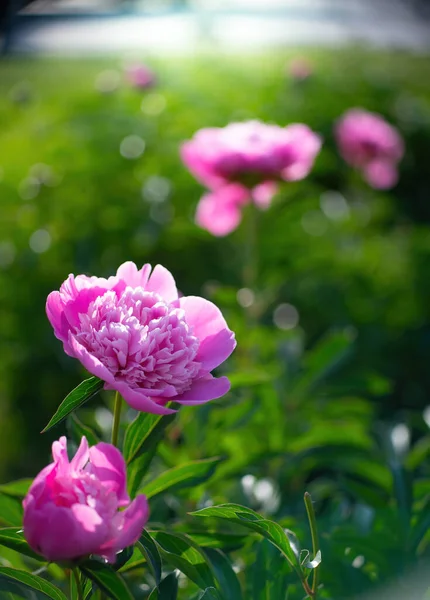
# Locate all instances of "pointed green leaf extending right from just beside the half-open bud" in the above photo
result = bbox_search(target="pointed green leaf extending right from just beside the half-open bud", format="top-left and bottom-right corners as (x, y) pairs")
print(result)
(142, 457), (224, 499)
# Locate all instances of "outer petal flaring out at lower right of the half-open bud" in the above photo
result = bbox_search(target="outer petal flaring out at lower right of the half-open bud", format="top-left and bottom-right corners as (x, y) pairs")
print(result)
(100, 495), (149, 562)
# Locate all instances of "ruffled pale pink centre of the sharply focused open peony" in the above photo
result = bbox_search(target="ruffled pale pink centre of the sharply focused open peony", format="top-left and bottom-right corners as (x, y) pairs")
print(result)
(74, 287), (200, 396)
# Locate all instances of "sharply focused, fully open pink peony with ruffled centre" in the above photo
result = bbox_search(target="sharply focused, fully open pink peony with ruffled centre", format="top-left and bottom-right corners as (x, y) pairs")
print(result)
(46, 262), (236, 414)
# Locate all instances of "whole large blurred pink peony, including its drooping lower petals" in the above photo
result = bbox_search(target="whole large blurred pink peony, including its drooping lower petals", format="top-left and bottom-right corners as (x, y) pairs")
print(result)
(181, 121), (321, 236)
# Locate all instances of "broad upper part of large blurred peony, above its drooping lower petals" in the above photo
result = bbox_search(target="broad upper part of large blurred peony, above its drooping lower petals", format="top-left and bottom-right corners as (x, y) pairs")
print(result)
(181, 121), (321, 189)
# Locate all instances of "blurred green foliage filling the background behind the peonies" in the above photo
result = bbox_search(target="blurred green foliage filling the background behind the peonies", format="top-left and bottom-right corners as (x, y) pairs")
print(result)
(0, 49), (430, 600)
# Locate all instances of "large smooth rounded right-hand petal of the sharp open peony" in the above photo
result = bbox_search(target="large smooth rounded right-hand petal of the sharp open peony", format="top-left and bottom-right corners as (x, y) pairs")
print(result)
(179, 296), (236, 371)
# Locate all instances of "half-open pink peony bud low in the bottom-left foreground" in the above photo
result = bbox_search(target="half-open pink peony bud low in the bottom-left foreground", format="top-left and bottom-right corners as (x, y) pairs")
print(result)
(23, 437), (148, 563)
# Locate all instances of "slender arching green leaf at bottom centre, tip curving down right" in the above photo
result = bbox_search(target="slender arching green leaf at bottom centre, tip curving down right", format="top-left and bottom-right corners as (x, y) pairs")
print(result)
(190, 504), (301, 573)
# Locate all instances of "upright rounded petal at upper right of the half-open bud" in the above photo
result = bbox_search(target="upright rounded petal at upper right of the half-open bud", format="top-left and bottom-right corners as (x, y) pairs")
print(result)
(89, 442), (130, 506)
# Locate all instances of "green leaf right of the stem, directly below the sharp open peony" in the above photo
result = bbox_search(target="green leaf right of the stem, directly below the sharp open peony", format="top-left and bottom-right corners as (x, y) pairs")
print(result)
(123, 413), (176, 464)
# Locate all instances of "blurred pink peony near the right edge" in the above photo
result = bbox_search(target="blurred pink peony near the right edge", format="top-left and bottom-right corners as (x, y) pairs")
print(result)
(335, 108), (404, 189)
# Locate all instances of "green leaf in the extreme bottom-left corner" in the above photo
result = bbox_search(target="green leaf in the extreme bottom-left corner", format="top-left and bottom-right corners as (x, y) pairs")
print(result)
(0, 567), (67, 600)
